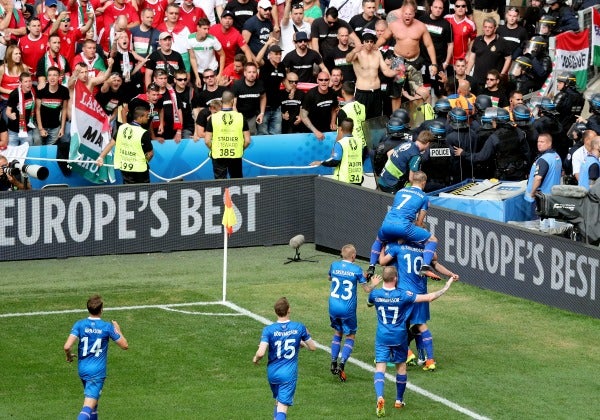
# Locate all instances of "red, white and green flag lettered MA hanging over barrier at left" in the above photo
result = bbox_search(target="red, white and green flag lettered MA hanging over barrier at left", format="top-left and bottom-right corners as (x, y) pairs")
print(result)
(69, 80), (115, 184)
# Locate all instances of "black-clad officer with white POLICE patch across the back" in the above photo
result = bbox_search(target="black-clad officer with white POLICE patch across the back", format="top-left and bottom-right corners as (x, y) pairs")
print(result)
(421, 120), (455, 192)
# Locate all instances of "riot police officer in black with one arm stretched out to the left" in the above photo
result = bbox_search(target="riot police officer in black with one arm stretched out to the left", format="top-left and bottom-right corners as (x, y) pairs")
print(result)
(454, 108), (529, 181)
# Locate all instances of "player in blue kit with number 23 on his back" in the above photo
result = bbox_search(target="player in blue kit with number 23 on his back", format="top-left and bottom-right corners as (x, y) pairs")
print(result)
(329, 244), (377, 382)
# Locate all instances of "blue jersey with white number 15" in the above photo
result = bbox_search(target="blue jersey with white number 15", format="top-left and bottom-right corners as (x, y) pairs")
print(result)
(260, 321), (310, 384)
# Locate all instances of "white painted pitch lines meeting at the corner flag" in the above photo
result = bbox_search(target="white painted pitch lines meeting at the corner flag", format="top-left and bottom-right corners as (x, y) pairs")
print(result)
(0, 301), (490, 420)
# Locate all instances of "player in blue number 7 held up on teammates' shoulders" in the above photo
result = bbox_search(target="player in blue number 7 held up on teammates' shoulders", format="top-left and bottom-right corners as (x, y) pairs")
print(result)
(367, 171), (437, 278)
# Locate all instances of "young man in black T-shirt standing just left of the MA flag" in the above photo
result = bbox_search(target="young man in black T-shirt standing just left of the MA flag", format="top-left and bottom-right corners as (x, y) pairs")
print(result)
(35, 67), (69, 145)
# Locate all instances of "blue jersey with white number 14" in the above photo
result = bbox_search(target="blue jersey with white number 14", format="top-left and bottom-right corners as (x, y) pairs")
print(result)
(71, 318), (121, 380)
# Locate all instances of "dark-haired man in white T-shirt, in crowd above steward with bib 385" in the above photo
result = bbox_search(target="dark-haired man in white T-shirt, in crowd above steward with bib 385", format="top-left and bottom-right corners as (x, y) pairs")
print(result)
(188, 18), (225, 88)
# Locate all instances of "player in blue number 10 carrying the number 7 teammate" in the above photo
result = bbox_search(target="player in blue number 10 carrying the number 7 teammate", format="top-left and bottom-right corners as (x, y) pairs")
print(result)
(379, 243), (459, 371)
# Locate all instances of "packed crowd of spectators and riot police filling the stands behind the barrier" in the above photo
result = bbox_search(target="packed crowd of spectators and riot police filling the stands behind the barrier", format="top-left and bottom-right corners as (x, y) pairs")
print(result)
(0, 0), (600, 192)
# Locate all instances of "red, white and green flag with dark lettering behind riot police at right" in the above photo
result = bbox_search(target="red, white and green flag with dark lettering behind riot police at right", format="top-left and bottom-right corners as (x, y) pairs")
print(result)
(556, 28), (590, 91)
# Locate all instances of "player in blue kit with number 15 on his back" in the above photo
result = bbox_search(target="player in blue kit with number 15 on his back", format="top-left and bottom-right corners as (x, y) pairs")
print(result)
(252, 297), (317, 420)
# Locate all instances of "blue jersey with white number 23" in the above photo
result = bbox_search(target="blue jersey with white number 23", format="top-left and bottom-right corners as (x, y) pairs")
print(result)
(329, 260), (367, 319)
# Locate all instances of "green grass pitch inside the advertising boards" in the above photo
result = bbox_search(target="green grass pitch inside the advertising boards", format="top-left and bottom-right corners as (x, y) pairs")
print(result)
(0, 244), (600, 419)
